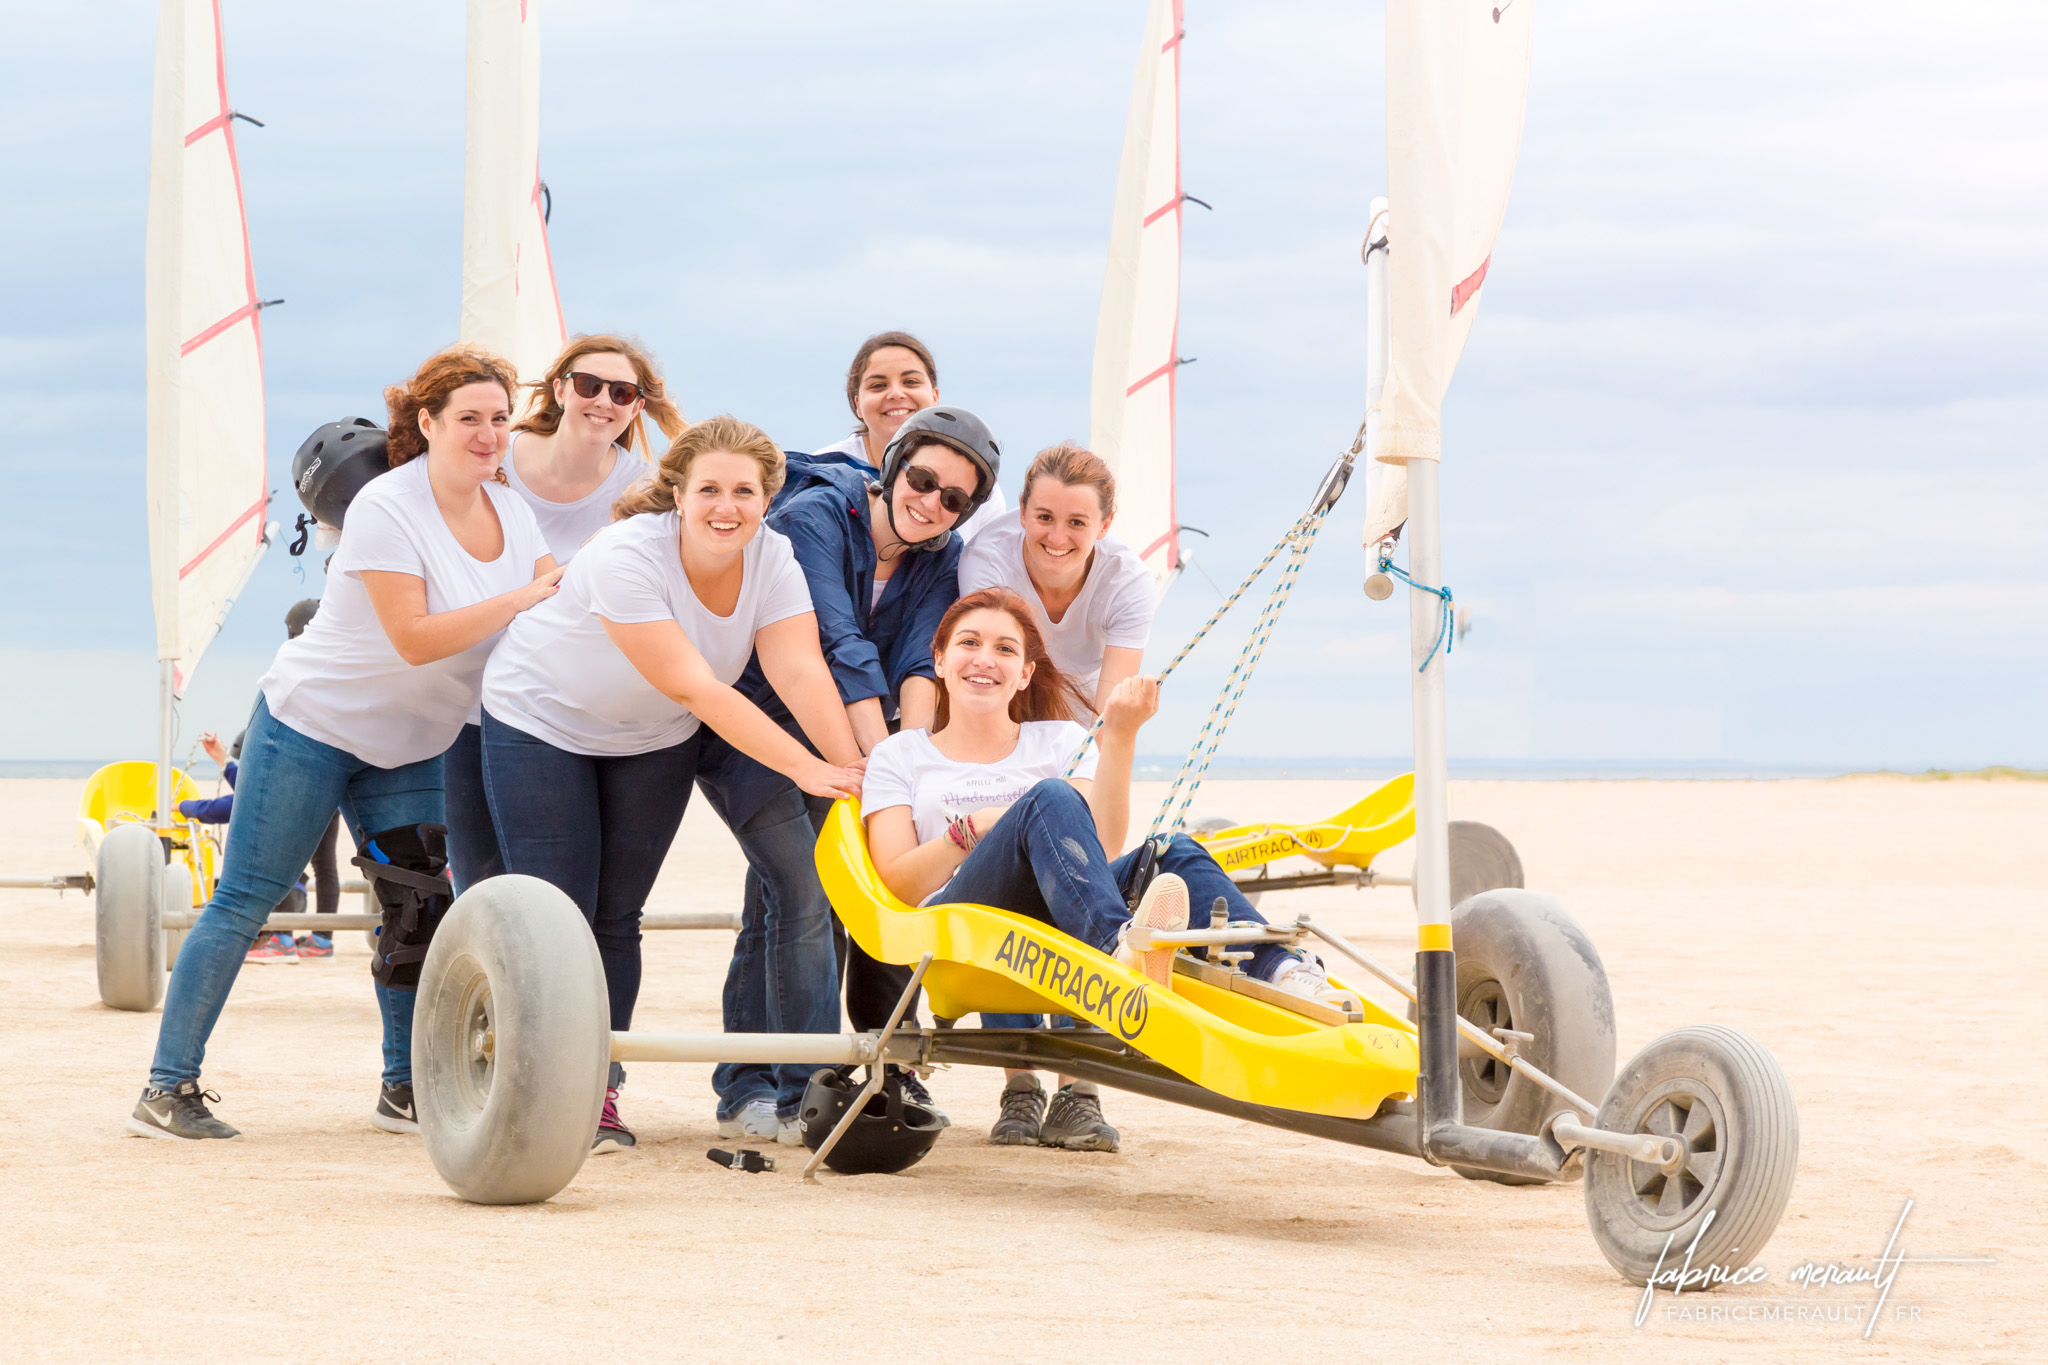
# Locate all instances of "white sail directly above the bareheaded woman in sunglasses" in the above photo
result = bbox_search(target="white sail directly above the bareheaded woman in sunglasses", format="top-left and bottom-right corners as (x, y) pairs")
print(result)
(461, 0), (569, 379)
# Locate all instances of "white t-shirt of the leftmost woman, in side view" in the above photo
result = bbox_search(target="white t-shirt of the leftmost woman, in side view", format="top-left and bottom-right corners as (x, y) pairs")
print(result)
(256, 456), (547, 767)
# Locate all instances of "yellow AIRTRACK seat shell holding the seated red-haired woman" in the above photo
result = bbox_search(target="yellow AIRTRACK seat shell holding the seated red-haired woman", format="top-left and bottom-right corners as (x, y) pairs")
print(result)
(817, 800), (1417, 1117)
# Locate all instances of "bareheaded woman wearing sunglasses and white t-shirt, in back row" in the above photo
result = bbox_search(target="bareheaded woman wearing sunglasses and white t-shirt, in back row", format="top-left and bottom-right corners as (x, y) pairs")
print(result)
(446, 336), (684, 892)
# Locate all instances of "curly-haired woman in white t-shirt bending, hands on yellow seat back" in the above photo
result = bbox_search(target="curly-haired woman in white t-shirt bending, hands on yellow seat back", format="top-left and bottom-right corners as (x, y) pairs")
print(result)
(483, 417), (860, 1152)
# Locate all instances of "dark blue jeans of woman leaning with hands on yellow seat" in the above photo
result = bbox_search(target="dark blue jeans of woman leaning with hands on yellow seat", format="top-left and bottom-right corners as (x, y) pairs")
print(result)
(483, 712), (702, 1031)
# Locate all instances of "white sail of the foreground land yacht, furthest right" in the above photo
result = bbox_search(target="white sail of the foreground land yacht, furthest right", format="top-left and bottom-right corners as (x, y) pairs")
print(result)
(1364, 0), (1534, 546)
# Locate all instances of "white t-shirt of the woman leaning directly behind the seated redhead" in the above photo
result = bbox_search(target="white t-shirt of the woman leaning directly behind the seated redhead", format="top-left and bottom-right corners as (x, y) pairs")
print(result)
(961, 516), (1157, 706)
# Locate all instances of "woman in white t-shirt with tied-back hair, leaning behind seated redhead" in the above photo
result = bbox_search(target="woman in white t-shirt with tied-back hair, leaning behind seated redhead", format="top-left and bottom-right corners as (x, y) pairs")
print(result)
(961, 442), (1155, 1152)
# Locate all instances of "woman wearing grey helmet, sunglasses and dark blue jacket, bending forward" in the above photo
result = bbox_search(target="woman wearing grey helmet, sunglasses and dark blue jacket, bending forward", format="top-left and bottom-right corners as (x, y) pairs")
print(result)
(702, 405), (1001, 1103)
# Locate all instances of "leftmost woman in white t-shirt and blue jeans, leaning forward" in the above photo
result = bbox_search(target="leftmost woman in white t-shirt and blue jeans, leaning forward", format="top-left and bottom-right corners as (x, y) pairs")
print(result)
(127, 348), (561, 1140)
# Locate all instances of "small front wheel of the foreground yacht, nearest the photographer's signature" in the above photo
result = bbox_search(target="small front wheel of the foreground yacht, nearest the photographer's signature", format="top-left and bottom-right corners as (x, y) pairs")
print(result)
(1585, 1025), (1798, 1285)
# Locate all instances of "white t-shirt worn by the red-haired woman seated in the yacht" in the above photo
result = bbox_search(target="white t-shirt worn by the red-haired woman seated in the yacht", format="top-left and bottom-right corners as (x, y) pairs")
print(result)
(860, 720), (1096, 905)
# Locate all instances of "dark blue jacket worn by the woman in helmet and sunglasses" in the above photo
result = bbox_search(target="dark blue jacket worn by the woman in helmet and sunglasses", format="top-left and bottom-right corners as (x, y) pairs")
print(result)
(698, 452), (961, 825)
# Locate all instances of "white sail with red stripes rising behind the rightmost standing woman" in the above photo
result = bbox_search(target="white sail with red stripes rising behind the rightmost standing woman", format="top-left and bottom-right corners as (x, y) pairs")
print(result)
(1087, 0), (1182, 591)
